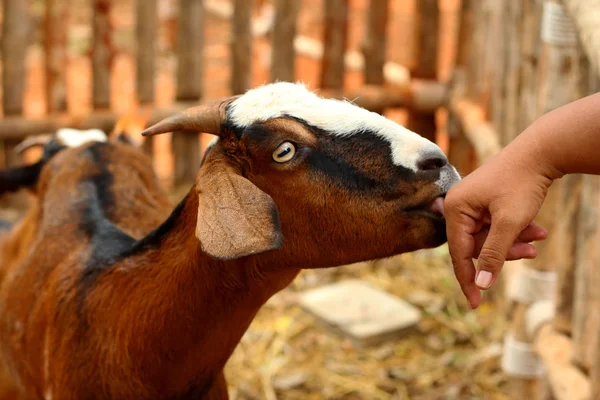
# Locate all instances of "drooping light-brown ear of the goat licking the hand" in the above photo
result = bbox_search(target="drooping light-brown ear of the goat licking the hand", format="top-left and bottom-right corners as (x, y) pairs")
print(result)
(196, 160), (283, 260)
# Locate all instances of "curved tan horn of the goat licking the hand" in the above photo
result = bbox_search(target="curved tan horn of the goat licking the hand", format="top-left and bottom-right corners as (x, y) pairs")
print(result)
(142, 95), (241, 136)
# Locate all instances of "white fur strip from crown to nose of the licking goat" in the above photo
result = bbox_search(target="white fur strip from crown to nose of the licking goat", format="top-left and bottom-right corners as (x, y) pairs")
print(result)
(228, 82), (445, 171)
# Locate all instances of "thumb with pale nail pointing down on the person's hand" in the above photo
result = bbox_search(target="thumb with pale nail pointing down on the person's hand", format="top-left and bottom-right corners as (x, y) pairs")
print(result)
(475, 216), (527, 289)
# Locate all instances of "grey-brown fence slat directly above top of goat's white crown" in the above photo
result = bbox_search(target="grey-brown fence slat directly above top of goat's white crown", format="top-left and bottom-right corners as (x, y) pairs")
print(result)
(271, 0), (300, 82)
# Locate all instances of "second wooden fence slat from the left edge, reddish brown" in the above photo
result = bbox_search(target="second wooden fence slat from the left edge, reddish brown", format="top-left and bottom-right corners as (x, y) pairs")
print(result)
(44, 0), (70, 113)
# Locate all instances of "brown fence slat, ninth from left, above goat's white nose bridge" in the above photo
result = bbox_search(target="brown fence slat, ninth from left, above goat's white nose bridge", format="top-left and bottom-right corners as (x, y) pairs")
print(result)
(362, 0), (390, 113)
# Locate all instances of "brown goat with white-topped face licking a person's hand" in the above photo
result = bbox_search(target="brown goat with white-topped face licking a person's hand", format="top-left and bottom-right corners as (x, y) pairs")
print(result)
(0, 83), (459, 400)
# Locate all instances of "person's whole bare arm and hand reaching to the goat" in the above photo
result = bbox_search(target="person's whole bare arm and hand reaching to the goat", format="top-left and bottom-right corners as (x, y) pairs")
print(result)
(445, 94), (600, 307)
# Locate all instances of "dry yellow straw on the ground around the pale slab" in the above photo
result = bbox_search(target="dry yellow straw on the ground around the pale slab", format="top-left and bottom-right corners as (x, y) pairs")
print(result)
(226, 246), (508, 400)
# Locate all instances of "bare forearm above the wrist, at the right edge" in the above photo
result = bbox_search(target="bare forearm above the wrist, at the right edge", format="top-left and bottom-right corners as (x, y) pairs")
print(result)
(506, 93), (600, 179)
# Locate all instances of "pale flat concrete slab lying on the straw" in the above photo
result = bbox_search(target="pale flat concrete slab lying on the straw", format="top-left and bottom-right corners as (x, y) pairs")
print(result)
(299, 280), (421, 346)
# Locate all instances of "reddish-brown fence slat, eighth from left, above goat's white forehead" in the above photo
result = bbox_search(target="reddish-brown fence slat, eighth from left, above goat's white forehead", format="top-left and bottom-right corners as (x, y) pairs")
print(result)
(321, 0), (349, 89)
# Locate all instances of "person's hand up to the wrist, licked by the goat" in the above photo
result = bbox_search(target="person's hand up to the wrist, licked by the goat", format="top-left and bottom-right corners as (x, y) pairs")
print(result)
(444, 150), (552, 308)
